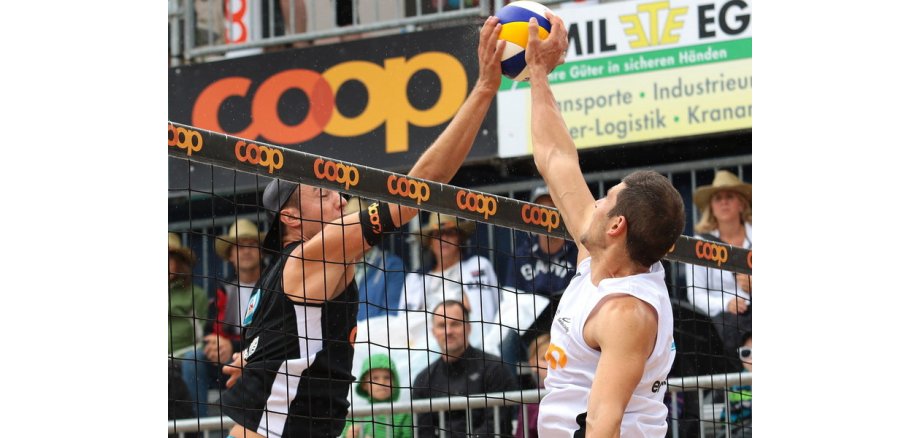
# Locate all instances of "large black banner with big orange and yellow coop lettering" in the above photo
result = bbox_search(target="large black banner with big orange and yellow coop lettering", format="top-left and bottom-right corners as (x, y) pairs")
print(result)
(169, 26), (497, 170)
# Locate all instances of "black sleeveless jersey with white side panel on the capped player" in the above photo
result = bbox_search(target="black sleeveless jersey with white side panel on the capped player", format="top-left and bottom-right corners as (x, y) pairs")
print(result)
(222, 242), (358, 437)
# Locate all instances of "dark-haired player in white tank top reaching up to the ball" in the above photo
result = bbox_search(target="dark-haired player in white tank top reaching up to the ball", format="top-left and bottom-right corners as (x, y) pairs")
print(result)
(524, 12), (686, 438)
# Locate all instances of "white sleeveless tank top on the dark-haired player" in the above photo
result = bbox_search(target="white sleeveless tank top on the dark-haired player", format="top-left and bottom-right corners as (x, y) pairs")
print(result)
(538, 257), (676, 438)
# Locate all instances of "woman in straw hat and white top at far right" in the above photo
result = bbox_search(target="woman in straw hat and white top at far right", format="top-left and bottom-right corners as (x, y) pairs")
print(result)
(687, 170), (753, 317)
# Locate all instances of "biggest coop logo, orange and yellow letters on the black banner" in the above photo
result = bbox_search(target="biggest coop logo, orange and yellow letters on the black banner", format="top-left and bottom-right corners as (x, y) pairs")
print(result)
(192, 52), (467, 153)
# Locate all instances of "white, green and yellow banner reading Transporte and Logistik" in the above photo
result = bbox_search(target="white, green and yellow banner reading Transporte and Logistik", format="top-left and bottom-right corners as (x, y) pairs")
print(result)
(498, 0), (752, 157)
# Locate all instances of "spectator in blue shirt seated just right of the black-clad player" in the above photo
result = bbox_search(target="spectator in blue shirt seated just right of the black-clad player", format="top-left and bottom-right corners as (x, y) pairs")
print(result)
(345, 196), (406, 321)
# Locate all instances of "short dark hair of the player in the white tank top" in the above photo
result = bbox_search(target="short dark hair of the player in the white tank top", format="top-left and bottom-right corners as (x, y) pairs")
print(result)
(607, 170), (684, 266)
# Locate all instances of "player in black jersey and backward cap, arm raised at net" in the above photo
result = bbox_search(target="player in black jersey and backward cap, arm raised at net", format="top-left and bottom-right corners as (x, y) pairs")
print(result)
(223, 17), (504, 438)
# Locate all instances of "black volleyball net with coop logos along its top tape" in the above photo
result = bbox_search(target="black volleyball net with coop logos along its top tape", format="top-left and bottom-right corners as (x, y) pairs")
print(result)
(168, 122), (752, 436)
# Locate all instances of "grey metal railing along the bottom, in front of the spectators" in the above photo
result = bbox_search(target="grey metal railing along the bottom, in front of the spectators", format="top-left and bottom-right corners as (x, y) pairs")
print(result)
(168, 373), (753, 438)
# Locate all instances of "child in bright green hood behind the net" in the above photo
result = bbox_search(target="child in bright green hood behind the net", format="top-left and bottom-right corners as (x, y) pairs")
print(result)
(342, 354), (412, 438)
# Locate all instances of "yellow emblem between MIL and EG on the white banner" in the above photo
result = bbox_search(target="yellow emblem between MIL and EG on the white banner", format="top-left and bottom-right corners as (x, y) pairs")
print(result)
(620, 1), (689, 49)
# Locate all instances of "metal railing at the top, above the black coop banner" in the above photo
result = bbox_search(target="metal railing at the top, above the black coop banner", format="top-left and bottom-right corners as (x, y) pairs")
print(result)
(169, 0), (567, 66)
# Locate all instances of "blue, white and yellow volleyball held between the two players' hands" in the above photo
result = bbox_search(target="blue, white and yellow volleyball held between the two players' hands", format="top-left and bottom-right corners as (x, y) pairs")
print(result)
(495, 0), (551, 81)
